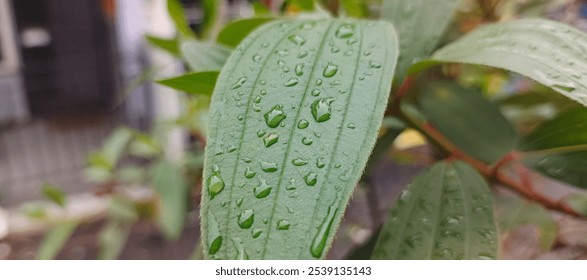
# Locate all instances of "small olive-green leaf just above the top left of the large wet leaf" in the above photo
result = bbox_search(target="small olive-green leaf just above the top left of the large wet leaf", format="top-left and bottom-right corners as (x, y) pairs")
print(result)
(216, 17), (274, 48)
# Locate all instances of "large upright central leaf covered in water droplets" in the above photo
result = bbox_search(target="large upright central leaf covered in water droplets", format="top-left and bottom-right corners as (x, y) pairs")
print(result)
(201, 19), (397, 259)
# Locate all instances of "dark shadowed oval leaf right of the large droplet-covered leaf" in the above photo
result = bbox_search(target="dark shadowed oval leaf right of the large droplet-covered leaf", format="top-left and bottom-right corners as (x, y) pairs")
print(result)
(418, 82), (517, 163)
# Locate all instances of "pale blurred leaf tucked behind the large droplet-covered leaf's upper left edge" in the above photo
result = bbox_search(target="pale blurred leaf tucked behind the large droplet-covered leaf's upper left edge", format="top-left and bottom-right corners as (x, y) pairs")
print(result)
(181, 40), (232, 72)
